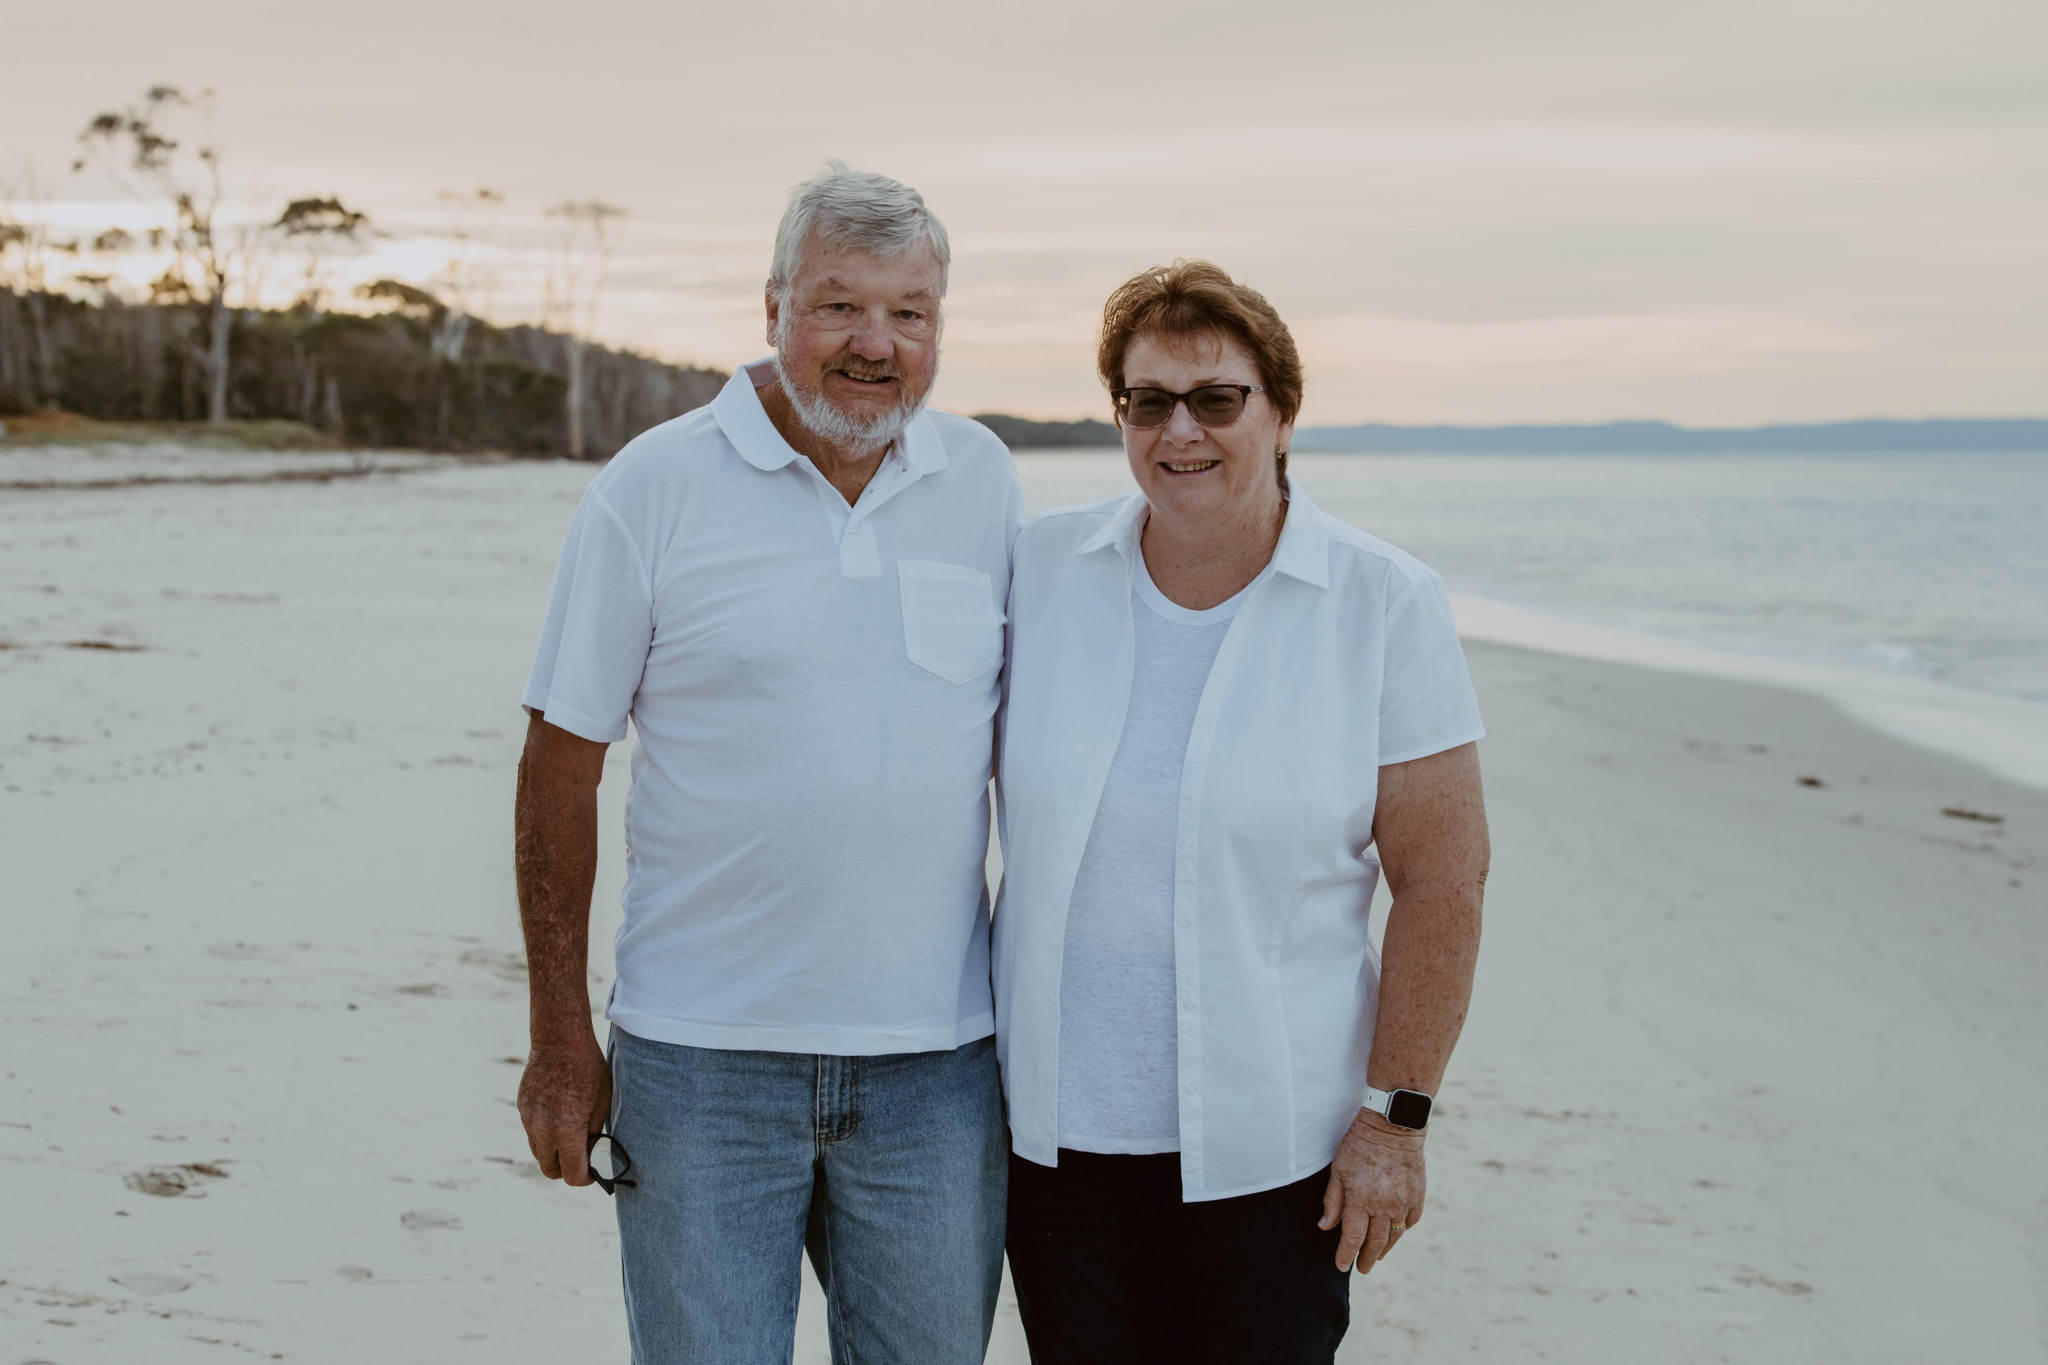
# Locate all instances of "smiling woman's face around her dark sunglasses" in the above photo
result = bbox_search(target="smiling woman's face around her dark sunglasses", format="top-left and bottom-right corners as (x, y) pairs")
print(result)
(1124, 336), (1294, 524)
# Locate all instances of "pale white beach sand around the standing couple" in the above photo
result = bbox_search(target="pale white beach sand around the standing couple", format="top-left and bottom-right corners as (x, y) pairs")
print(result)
(0, 454), (2048, 1365)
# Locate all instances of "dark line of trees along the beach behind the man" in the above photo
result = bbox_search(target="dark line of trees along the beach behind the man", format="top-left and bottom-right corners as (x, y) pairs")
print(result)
(0, 86), (725, 458)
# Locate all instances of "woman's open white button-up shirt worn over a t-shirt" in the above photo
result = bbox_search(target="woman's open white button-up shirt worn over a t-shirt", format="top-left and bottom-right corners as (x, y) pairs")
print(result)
(995, 487), (1483, 1201)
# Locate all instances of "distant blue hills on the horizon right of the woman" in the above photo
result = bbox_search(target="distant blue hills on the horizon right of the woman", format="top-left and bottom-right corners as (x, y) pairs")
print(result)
(1292, 417), (2048, 454)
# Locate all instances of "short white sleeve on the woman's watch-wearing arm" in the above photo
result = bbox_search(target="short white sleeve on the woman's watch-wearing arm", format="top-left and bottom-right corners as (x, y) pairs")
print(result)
(1380, 571), (1487, 767)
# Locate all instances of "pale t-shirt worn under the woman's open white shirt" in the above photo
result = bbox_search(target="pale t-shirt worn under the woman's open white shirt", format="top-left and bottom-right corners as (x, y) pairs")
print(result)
(1059, 555), (1243, 1154)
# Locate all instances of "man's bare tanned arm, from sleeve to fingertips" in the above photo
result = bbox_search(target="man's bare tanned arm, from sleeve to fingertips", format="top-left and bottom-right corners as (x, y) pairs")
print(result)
(512, 712), (612, 1185)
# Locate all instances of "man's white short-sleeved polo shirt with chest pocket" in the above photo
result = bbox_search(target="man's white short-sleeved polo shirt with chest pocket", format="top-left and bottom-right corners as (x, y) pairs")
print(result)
(524, 362), (1024, 1056)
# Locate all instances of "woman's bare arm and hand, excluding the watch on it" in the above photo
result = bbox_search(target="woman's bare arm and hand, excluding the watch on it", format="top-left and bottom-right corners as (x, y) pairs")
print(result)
(1321, 745), (1489, 1273)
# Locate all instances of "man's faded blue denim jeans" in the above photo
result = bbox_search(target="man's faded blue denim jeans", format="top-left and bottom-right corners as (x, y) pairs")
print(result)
(612, 1029), (1010, 1365)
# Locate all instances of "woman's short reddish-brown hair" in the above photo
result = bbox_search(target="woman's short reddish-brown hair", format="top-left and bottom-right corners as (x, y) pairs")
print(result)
(1096, 260), (1300, 437)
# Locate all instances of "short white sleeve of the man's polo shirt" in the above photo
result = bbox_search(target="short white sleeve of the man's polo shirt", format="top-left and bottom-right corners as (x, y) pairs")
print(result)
(520, 489), (653, 745)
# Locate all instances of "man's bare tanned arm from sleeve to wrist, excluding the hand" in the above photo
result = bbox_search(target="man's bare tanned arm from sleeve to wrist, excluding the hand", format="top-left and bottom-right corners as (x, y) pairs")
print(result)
(512, 724), (602, 1044)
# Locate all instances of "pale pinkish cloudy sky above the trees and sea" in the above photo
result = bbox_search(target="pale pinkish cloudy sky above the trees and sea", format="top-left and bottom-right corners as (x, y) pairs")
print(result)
(0, 0), (2048, 426)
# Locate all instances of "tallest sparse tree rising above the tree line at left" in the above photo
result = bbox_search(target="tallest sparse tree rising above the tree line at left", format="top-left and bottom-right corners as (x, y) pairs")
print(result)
(72, 86), (248, 422)
